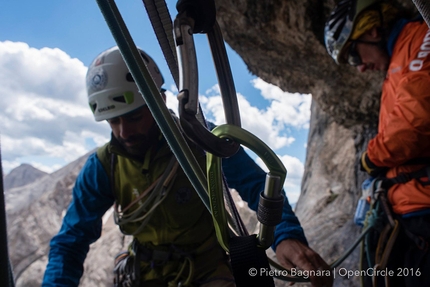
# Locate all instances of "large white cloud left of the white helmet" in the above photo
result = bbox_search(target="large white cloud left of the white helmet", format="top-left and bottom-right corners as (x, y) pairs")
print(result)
(0, 41), (109, 173)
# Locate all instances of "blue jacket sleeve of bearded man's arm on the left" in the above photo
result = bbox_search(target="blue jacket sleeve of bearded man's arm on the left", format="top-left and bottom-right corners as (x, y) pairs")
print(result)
(42, 153), (114, 287)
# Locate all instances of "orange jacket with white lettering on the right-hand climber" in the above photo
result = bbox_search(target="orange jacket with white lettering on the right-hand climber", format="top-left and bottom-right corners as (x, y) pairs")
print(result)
(367, 21), (430, 214)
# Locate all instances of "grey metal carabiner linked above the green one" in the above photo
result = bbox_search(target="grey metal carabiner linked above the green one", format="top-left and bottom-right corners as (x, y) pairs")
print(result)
(174, 10), (241, 157)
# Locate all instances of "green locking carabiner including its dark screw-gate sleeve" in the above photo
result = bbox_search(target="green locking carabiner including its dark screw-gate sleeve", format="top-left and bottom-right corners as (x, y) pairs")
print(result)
(207, 124), (287, 251)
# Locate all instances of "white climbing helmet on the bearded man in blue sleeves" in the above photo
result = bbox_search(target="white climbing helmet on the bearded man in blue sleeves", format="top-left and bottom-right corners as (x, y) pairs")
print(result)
(86, 47), (164, 121)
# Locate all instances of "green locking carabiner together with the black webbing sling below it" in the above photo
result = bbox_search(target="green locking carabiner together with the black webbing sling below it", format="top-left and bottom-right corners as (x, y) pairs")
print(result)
(206, 124), (287, 287)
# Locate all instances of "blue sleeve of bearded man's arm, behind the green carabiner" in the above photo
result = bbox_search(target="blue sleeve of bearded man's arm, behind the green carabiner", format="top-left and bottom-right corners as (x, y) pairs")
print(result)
(222, 147), (308, 250)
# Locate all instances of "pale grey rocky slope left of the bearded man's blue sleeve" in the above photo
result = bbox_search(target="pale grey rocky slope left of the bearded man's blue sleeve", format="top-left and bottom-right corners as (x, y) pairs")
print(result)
(5, 152), (92, 286)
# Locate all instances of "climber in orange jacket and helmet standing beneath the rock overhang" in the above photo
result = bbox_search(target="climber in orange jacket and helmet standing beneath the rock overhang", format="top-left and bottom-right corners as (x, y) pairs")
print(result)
(325, 0), (430, 286)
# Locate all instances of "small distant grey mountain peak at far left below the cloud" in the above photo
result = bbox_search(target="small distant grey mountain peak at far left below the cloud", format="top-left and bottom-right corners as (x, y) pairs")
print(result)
(4, 163), (48, 189)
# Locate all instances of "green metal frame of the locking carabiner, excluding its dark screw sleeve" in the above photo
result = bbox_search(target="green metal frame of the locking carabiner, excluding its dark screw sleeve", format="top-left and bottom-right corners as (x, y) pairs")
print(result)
(206, 124), (287, 251)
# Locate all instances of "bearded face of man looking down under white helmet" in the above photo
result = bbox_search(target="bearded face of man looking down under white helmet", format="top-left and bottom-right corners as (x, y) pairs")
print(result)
(107, 106), (158, 157)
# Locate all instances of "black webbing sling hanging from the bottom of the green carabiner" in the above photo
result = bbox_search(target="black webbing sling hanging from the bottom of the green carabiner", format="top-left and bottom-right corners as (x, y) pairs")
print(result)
(229, 234), (275, 287)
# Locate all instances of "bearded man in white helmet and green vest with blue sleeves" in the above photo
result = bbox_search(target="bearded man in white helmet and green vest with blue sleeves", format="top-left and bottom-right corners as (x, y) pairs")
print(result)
(42, 47), (332, 287)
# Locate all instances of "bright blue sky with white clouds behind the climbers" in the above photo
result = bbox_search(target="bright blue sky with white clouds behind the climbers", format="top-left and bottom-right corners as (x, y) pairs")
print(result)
(0, 0), (311, 202)
